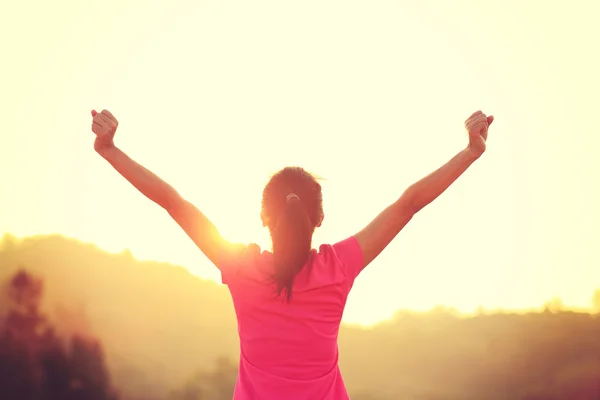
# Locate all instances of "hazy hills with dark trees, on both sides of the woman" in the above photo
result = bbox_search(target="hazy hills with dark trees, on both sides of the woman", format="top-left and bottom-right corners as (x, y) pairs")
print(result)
(0, 235), (600, 400)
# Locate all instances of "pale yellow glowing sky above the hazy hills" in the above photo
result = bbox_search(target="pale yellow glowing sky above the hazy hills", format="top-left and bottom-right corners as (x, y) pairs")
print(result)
(0, 0), (600, 324)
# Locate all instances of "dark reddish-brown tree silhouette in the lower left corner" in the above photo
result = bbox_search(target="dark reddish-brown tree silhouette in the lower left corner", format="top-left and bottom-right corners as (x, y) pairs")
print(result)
(0, 270), (117, 400)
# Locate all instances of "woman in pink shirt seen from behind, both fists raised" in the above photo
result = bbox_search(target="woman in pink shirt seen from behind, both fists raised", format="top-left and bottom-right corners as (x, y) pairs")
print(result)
(92, 110), (494, 400)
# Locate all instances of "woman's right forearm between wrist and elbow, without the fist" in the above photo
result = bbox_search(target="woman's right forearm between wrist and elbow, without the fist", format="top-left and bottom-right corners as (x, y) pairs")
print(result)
(403, 148), (477, 213)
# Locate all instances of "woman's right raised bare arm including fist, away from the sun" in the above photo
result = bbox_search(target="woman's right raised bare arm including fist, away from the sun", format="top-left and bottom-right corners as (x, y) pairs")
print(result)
(354, 111), (494, 268)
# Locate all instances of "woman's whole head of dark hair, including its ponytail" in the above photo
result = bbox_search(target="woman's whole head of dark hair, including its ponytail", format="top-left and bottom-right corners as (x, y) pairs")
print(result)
(262, 167), (323, 301)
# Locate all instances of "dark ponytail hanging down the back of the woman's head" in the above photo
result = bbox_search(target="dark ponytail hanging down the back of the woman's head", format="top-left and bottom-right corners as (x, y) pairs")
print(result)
(271, 193), (314, 302)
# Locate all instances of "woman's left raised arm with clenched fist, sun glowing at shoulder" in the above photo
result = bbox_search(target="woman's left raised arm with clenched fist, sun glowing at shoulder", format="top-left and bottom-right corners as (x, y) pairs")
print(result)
(92, 110), (239, 266)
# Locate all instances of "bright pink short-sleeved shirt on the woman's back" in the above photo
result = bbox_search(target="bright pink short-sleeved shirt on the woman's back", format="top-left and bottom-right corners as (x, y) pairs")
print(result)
(219, 237), (363, 400)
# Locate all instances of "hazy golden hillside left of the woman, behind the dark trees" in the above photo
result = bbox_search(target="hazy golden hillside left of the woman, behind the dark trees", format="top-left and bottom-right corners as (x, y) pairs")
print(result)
(0, 236), (239, 398)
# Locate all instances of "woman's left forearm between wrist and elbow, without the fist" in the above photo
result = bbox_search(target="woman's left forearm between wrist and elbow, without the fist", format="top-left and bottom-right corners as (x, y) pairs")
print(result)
(99, 147), (179, 211)
